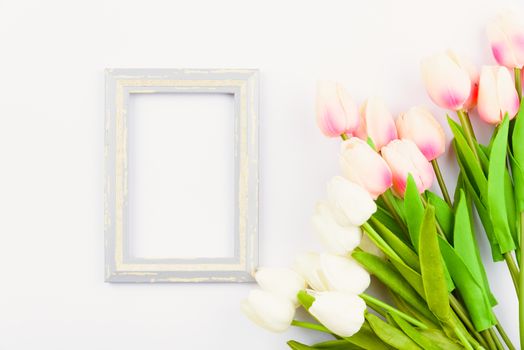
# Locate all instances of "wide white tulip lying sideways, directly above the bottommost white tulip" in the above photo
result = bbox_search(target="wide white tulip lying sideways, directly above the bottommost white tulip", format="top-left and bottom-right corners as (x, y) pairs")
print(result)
(295, 253), (371, 294)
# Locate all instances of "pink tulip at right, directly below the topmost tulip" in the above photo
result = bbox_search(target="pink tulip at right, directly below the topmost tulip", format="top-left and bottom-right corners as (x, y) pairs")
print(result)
(478, 66), (519, 124)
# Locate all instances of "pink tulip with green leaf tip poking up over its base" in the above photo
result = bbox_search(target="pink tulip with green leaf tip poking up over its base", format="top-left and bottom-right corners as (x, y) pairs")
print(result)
(382, 140), (433, 196)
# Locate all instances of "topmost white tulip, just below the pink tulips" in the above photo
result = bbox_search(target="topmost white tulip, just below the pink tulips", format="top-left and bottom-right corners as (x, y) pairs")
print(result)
(327, 176), (377, 226)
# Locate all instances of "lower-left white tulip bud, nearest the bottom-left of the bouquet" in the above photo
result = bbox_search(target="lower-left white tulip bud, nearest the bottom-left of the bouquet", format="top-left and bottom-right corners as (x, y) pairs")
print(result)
(240, 289), (295, 332)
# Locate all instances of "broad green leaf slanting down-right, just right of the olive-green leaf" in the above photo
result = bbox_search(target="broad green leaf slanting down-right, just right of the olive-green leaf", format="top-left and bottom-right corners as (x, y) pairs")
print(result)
(439, 239), (497, 331)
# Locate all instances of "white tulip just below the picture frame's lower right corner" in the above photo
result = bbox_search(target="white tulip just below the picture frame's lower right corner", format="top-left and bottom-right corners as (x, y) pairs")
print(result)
(255, 267), (306, 305)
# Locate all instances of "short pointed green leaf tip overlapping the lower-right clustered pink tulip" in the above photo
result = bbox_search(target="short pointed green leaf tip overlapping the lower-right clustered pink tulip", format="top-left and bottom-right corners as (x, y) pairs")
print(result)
(404, 174), (424, 250)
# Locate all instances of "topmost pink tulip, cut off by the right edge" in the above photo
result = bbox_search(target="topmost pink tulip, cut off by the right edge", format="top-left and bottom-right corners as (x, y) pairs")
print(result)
(487, 12), (524, 69)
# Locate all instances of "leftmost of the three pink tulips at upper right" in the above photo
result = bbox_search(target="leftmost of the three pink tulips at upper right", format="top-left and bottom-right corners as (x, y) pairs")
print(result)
(421, 53), (472, 111)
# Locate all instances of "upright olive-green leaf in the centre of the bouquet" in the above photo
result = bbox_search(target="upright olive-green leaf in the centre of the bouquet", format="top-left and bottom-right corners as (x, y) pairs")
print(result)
(418, 205), (451, 323)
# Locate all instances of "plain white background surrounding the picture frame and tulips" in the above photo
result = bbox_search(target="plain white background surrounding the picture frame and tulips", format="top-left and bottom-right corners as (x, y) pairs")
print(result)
(0, 0), (517, 350)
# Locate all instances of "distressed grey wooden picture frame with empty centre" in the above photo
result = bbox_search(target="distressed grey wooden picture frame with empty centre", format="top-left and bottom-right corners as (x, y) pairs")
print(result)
(104, 69), (258, 282)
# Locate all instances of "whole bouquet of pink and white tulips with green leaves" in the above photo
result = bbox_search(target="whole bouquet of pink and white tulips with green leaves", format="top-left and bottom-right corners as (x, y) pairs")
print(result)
(242, 13), (524, 350)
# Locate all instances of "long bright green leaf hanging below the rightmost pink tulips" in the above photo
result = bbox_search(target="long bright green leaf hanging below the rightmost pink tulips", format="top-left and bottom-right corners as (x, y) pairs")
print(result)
(487, 116), (516, 254)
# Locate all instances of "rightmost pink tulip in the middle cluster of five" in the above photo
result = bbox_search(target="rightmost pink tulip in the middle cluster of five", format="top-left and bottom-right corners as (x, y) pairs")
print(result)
(397, 107), (446, 161)
